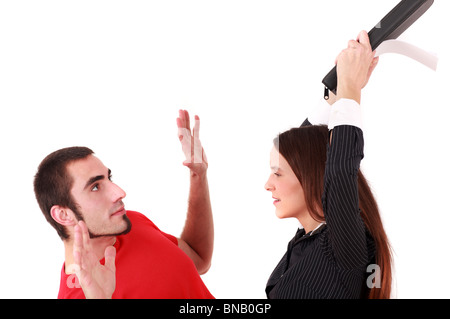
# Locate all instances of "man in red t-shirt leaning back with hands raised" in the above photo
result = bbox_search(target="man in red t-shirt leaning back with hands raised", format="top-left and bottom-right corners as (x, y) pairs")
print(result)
(34, 110), (214, 299)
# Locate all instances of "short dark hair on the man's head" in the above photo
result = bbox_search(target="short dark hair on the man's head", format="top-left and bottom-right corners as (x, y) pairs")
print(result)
(33, 146), (94, 240)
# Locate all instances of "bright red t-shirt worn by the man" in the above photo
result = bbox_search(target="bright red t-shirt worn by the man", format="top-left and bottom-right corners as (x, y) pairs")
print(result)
(58, 211), (214, 299)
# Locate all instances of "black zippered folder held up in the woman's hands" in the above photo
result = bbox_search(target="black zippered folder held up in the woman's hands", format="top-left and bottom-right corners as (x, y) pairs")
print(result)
(322, 0), (434, 98)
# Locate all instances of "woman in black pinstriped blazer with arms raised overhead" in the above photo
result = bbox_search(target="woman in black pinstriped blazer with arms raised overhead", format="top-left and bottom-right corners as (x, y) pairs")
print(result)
(265, 31), (391, 299)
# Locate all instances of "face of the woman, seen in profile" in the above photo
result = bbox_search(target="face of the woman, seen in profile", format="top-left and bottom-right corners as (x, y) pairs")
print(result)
(265, 147), (309, 220)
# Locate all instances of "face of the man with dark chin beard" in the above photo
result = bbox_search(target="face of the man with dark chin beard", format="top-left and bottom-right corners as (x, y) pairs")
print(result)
(67, 155), (131, 237)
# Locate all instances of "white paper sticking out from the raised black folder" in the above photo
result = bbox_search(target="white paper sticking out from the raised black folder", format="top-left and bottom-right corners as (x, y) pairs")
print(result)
(375, 40), (439, 71)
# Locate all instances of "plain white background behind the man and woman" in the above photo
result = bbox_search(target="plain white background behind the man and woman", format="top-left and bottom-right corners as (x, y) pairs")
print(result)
(0, 0), (450, 298)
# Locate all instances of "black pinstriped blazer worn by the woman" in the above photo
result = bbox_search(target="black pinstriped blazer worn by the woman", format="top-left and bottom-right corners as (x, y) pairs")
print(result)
(266, 120), (375, 299)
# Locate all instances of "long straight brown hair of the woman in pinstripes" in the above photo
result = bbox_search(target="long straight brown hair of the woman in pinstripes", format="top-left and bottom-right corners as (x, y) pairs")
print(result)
(274, 126), (392, 299)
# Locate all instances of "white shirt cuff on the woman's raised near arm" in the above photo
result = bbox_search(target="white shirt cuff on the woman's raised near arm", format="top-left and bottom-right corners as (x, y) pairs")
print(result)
(328, 99), (363, 130)
